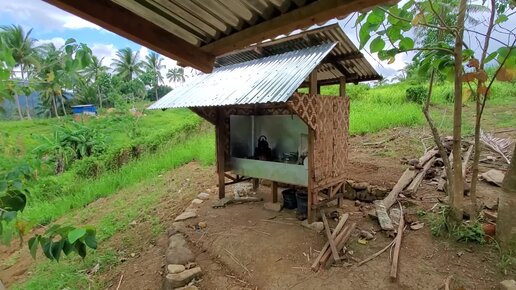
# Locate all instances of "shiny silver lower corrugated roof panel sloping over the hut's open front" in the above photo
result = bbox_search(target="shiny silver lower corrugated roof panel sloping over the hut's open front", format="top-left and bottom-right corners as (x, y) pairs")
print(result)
(149, 43), (336, 109)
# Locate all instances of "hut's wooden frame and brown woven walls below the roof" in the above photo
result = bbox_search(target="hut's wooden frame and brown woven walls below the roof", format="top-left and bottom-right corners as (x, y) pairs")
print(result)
(190, 69), (349, 221)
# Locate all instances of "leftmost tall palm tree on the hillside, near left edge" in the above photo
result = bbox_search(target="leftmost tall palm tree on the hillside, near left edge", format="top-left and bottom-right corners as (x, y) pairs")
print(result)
(0, 25), (37, 119)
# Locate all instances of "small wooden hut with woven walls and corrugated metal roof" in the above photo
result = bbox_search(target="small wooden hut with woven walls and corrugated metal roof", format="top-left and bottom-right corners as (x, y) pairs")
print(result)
(150, 24), (381, 220)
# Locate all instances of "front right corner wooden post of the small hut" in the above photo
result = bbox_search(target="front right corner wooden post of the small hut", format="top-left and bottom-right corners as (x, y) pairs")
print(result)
(307, 68), (317, 223)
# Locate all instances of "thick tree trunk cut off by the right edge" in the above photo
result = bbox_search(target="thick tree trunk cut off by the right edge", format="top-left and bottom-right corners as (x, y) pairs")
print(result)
(496, 147), (516, 253)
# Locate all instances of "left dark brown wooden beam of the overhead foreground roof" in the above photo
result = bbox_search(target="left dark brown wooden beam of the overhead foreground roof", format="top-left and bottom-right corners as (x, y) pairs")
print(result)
(44, 0), (215, 73)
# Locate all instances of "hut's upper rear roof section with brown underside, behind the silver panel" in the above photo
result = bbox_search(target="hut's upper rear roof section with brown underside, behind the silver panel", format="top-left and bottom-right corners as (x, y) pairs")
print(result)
(215, 24), (382, 84)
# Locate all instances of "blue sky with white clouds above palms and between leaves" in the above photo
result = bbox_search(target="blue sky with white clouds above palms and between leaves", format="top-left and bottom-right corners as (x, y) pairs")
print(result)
(0, 0), (516, 81)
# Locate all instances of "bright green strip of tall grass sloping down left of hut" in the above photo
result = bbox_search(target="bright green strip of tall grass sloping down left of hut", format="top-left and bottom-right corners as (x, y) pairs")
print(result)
(17, 131), (215, 230)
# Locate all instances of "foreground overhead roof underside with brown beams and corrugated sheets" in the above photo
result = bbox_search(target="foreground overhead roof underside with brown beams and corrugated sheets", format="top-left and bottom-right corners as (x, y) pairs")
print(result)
(44, 0), (396, 72)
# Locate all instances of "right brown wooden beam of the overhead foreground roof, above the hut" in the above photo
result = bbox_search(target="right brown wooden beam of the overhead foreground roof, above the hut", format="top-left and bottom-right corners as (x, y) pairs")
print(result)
(202, 0), (388, 55)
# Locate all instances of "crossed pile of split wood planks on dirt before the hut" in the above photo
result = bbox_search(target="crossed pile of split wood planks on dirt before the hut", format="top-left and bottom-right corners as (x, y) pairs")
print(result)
(311, 211), (357, 272)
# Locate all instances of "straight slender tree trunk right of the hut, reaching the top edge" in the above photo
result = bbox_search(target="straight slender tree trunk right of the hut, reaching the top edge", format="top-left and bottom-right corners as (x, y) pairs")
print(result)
(448, 0), (468, 222)
